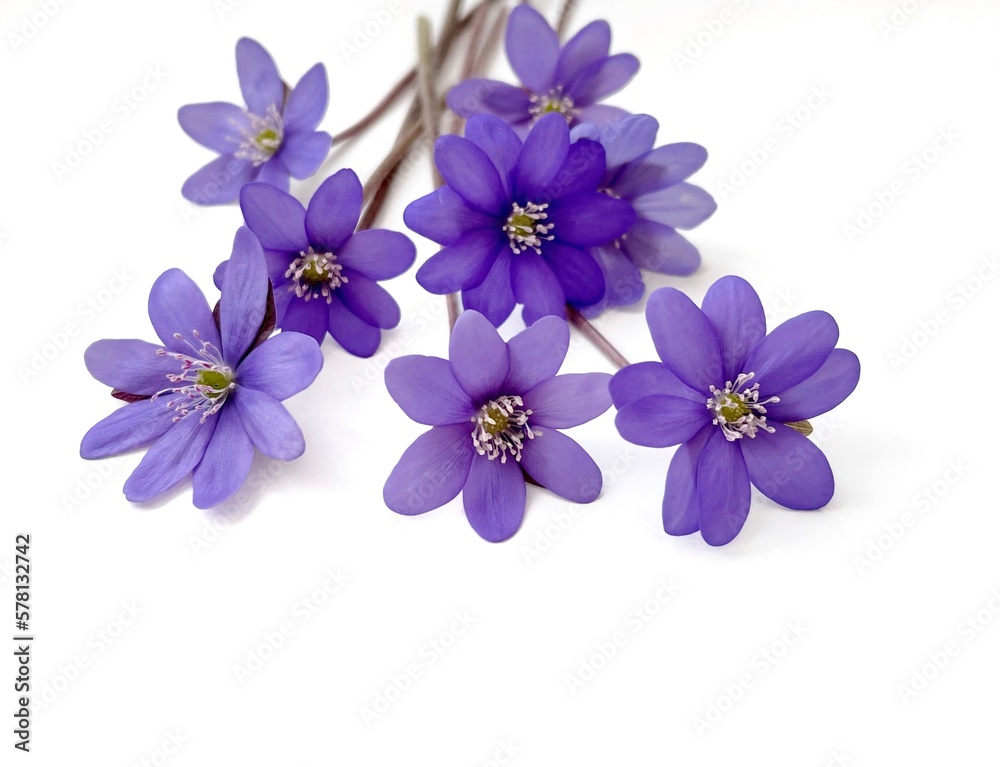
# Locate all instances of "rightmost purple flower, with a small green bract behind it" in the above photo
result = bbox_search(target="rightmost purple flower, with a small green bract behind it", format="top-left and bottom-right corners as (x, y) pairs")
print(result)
(611, 277), (861, 546)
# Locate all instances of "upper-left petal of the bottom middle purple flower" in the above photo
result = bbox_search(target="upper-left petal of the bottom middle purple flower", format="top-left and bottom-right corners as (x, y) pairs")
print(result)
(385, 354), (476, 434)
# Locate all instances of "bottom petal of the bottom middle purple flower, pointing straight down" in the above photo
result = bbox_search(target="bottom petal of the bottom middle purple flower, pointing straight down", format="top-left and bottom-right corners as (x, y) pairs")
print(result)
(462, 458), (525, 543)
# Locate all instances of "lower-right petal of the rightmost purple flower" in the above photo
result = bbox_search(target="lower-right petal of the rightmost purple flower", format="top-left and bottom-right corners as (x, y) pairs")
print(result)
(739, 424), (833, 510)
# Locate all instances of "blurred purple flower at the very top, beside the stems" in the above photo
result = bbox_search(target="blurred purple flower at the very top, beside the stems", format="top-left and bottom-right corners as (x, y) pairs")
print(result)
(447, 4), (639, 136)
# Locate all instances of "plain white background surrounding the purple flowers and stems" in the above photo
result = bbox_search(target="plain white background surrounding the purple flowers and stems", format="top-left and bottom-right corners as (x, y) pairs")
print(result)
(0, 0), (1000, 767)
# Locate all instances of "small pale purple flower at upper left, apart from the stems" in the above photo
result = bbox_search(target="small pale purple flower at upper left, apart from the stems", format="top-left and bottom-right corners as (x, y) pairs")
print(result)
(177, 37), (331, 205)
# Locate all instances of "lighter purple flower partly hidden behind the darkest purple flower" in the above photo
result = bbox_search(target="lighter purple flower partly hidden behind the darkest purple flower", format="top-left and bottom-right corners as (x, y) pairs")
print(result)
(572, 115), (717, 316)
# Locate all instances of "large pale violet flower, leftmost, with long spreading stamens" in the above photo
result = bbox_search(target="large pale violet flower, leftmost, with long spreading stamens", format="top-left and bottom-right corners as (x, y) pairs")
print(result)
(80, 228), (323, 508)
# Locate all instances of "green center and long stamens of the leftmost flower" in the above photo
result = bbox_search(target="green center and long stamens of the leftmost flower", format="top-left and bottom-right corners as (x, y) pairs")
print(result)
(150, 330), (236, 423)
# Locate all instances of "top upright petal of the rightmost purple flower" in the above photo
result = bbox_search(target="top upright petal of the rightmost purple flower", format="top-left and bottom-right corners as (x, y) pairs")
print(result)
(701, 276), (767, 381)
